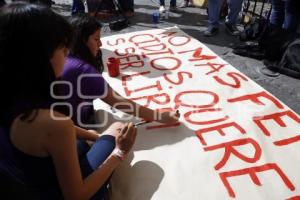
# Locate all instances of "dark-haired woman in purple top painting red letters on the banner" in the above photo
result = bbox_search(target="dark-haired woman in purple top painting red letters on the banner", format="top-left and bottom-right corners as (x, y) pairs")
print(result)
(61, 15), (179, 130)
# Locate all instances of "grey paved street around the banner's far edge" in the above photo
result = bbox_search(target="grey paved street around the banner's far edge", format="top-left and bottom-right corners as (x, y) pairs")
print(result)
(53, 0), (300, 114)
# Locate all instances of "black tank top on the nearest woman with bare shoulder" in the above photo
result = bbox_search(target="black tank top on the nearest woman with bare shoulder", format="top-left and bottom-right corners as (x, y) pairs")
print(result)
(0, 103), (63, 199)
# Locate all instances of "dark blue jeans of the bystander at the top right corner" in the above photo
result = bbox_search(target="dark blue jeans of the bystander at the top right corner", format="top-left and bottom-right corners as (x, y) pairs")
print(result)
(270, 0), (299, 31)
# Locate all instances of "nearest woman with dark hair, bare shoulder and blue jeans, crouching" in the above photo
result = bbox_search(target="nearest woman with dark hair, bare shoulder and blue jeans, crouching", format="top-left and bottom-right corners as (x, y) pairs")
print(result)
(0, 2), (136, 200)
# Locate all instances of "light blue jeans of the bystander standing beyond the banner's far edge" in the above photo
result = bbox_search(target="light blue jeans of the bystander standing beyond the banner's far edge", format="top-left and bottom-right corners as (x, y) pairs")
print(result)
(208, 0), (243, 27)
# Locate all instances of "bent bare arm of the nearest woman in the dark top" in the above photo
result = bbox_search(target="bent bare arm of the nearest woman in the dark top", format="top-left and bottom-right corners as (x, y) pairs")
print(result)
(45, 111), (136, 200)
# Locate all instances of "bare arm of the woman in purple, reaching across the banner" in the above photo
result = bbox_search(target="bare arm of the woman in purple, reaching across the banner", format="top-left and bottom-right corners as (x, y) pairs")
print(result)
(102, 85), (180, 123)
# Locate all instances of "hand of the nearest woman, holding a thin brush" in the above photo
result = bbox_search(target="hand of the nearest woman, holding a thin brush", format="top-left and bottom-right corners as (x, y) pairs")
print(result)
(116, 122), (137, 155)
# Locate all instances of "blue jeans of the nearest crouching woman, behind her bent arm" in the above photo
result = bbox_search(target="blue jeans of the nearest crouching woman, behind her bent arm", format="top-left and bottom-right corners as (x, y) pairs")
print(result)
(77, 135), (116, 200)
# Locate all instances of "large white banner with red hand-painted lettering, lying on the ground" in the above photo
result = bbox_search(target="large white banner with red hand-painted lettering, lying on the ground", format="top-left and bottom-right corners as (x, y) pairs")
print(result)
(102, 27), (300, 200)
